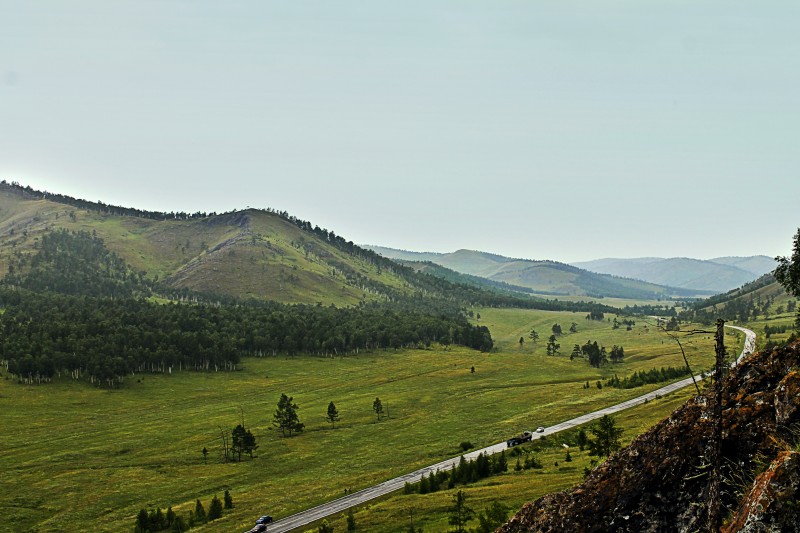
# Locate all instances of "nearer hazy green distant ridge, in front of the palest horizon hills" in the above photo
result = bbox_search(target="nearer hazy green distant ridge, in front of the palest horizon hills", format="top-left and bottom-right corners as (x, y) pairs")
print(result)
(362, 245), (713, 299)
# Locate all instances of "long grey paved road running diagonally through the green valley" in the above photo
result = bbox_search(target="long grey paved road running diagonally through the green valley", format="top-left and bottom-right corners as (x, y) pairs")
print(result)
(269, 326), (756, 533)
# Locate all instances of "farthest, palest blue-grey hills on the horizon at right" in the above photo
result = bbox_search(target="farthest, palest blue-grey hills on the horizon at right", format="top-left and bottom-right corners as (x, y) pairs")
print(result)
(572, 255), (776, 293)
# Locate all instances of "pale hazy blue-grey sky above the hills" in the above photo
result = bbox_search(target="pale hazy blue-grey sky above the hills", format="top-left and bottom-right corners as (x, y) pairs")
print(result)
(0, 0), (800, 261)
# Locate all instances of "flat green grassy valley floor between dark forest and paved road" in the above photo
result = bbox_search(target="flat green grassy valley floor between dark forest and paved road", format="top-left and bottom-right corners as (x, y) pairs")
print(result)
(0, 309), (724, 532)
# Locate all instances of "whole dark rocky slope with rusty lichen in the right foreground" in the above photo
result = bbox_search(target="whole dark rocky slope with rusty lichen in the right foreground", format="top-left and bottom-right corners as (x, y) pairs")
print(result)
(498, 343), (800, 533)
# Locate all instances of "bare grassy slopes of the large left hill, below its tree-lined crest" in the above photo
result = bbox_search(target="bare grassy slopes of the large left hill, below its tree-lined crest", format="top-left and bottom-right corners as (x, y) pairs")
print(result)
(0, 187), (404, 305)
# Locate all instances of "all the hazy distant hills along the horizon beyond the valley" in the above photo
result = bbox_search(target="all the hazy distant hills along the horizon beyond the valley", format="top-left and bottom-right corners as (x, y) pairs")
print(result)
(364, 246), (775, 295)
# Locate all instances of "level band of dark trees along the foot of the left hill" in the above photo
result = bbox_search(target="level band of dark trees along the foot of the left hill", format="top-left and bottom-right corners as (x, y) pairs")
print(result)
(0, 288), (493, 386)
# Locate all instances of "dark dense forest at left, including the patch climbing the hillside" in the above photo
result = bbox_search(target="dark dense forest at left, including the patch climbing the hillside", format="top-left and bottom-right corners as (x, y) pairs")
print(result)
(0, 230), (492, 386)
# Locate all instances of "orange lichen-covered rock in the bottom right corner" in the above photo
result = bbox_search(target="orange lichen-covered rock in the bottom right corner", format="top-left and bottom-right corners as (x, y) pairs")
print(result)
(722, 452), (800, 533)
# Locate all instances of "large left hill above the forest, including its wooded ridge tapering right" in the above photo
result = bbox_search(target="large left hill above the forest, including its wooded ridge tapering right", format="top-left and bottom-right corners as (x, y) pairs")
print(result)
(0, 181), (608, 311)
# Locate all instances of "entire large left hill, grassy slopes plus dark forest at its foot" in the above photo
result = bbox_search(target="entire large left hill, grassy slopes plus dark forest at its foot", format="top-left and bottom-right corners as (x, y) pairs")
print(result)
(0, 183), (609, 386)
